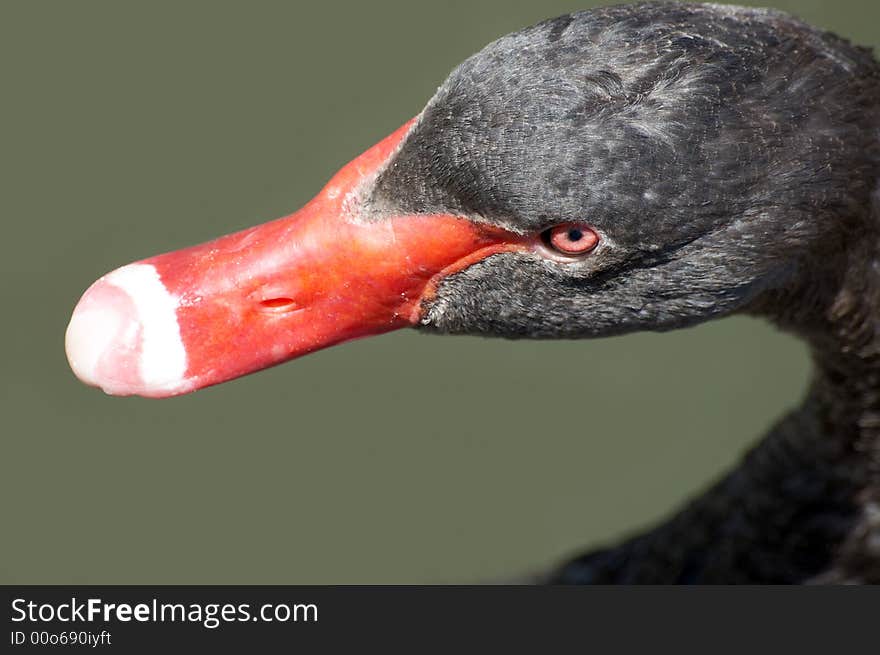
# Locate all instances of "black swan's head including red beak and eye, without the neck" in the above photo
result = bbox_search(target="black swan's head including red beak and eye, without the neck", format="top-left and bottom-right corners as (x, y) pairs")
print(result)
(67, 3), (880, 397)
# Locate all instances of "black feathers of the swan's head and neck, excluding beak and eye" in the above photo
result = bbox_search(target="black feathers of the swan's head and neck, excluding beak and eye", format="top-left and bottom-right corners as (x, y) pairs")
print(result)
(360, 2), (880, 582)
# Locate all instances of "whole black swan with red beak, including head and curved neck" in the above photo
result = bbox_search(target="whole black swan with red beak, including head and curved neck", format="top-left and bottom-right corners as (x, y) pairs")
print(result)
(66, 2), (880, 583)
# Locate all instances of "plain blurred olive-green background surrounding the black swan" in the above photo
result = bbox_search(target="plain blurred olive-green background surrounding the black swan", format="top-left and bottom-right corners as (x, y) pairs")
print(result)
(0, 0), (880, 583)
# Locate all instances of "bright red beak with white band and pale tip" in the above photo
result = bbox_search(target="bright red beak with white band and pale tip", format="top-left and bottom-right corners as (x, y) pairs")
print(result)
(66, 121), (530, 397)
